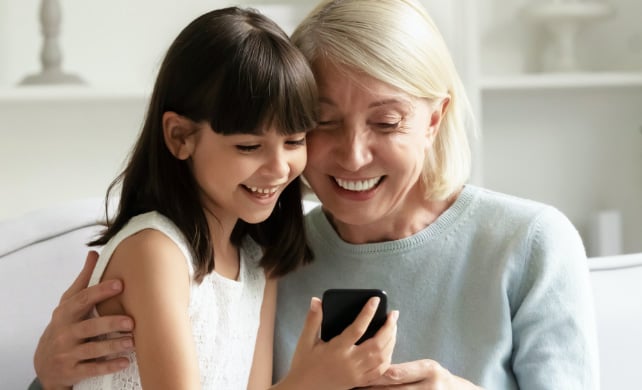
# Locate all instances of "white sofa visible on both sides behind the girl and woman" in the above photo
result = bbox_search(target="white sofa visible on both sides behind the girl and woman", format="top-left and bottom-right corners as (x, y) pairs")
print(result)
(0, 199), (642, 390)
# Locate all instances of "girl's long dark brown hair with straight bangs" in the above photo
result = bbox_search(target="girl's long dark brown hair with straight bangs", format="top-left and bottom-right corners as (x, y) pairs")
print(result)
(89, 7), (317, 281)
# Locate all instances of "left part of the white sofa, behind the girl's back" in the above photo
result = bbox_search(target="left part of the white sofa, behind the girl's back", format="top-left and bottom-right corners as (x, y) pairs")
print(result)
(0, 199), (102, 389)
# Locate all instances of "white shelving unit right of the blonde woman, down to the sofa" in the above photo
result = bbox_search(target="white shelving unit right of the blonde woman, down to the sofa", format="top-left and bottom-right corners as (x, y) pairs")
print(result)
(459, 0), (642, 255)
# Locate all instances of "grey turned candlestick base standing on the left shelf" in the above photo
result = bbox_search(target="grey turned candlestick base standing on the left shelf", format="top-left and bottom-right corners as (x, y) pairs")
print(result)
(20, 0), (84, 85)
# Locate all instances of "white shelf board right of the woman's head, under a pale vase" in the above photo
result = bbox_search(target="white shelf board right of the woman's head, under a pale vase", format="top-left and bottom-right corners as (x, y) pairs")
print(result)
(479, 72), (642, 91)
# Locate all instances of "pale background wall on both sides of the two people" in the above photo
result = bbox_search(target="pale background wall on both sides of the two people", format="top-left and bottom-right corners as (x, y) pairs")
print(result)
(0, 0), (642, 251)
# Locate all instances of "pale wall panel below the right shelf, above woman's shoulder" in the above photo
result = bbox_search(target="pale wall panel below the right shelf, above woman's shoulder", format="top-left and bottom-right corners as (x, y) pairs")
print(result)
(483, 87), (642, 253)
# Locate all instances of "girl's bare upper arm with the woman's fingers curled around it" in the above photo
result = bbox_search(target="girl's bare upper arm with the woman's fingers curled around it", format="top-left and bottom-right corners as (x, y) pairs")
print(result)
(98, 229), (200, 389)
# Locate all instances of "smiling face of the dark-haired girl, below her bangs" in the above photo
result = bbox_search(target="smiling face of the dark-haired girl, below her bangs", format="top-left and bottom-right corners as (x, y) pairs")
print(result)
(191, 124), (306, 227)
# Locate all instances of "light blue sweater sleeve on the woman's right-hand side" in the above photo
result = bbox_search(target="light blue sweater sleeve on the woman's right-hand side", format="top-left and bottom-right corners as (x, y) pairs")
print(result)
(509, 207), (599, 390)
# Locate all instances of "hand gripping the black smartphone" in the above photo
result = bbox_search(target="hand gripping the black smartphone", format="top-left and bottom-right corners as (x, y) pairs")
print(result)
(275, 297), (399, 390)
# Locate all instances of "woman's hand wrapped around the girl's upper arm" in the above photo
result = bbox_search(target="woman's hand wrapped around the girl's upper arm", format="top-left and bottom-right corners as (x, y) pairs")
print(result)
(33, 252), (134, 389)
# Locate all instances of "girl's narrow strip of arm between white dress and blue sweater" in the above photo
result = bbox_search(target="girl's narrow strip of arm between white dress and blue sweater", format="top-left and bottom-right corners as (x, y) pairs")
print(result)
(247, 279), (277, 390)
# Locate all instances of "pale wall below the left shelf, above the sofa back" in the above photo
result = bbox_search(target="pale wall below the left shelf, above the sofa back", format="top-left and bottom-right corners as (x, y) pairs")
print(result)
(0, 98), (144, 218)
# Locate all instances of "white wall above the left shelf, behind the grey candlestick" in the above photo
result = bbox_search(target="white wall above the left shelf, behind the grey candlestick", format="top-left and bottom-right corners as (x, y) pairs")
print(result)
(0, 0), (455, 89)
